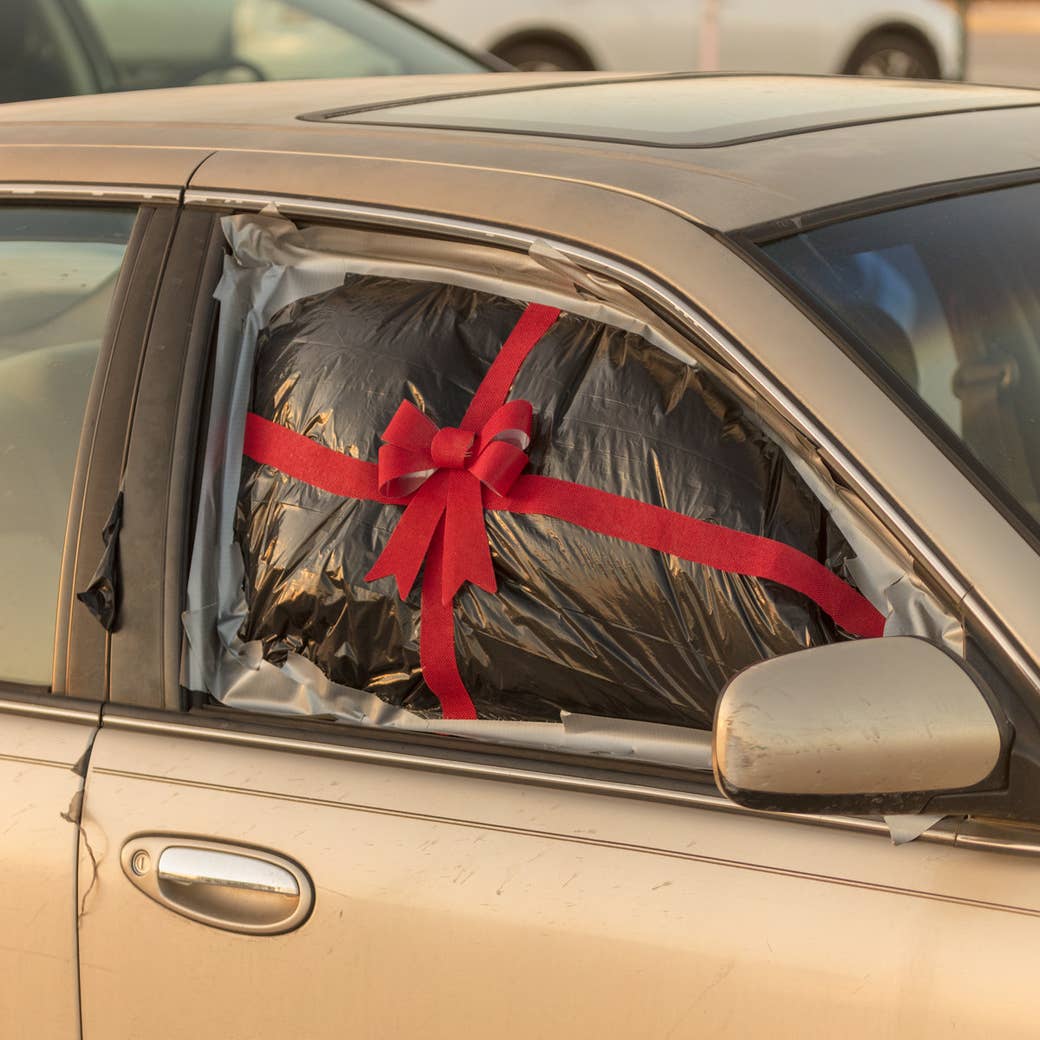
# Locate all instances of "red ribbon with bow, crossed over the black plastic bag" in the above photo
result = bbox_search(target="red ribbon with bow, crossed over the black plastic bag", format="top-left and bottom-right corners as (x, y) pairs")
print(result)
(242, 304), (884, 719)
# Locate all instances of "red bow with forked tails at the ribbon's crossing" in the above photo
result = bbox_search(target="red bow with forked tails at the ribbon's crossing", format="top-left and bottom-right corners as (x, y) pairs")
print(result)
(365, 400), (532, 604)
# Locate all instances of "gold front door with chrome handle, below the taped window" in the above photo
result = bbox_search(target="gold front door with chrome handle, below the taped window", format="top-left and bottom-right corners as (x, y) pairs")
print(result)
(79, 192), (1040, 1040)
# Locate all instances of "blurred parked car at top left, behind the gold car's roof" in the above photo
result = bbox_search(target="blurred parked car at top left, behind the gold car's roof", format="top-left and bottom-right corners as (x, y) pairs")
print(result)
(0, 0), (496, 102)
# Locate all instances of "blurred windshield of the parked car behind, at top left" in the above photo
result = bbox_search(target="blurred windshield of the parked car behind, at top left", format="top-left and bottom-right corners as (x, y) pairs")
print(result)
(76, 0), (488, 90)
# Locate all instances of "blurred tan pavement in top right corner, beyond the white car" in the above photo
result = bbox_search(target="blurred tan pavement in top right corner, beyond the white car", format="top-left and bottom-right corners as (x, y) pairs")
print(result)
(966, 0), (1040, 86)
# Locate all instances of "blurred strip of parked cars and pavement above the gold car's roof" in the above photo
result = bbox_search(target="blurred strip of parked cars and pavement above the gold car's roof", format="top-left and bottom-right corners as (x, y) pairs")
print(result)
(0, 0), (1040, 101)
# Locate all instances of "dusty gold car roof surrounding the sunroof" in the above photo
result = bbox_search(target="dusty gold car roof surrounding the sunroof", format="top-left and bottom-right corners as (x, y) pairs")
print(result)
(0, 74), (1040, 231)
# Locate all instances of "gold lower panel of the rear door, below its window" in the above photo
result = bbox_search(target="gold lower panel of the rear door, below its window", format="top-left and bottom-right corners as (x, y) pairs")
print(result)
(0, 694), (99, 1040)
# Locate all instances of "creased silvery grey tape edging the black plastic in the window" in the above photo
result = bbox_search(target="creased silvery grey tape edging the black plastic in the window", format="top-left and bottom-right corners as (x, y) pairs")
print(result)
(182, 214), (956, 744)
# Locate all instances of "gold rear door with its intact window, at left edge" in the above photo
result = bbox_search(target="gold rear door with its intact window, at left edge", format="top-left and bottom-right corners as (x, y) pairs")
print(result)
(0, 193), (174, 1040)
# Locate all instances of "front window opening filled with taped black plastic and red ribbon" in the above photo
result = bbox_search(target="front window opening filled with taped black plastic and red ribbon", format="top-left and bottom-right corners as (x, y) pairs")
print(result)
(184, 213), (960, 768)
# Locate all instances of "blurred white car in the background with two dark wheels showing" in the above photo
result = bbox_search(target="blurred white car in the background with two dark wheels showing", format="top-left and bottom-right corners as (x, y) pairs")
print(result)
(394, 0), (964, 79)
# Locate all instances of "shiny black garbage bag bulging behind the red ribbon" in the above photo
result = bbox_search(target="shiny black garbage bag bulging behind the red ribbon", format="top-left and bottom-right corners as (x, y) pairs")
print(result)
(236, 276), (861, 728)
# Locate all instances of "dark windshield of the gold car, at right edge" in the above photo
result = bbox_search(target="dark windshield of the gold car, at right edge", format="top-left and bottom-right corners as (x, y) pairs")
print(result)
(763, 184), (1040, 529)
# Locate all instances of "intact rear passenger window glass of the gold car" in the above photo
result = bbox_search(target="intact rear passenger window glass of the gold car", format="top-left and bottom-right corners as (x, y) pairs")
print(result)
(0, 206), (134, 685)
